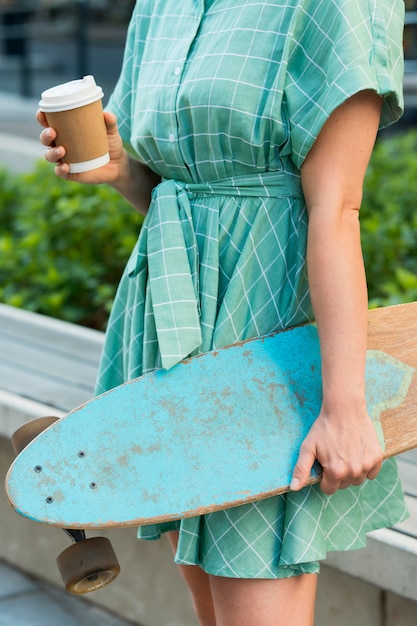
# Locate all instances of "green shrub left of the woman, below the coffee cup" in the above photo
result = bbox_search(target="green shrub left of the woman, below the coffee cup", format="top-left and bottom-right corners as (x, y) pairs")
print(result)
(0, 161), (142, 329)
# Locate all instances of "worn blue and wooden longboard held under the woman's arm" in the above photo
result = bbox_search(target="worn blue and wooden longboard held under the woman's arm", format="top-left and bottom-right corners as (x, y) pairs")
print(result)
(6, 303), (417, 593)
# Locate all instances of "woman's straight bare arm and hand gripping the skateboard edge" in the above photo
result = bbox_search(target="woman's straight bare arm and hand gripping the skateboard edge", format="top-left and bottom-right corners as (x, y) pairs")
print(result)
(292, 91), (382, 494)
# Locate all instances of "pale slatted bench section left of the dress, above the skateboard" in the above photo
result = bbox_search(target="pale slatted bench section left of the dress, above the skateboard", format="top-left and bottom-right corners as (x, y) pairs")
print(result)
(0, 305), (104, 437)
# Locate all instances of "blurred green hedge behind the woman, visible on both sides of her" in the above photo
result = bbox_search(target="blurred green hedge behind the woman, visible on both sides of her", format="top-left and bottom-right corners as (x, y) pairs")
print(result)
(0, 130), (417, 329)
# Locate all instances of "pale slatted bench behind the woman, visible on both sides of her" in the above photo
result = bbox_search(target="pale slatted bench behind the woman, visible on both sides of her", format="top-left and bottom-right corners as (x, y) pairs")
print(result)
(0, 305), (417, 623)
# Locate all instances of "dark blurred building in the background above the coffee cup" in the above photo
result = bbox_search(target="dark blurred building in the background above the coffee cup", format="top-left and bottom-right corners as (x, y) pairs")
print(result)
(0, 0), (135, 97)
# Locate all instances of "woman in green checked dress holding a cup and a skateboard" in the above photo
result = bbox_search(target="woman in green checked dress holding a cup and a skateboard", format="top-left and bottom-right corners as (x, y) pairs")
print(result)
(38, 0), (406, 626)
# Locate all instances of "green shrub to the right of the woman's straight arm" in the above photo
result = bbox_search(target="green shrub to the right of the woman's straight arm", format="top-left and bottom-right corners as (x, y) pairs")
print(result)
(361, 130), (417, 307)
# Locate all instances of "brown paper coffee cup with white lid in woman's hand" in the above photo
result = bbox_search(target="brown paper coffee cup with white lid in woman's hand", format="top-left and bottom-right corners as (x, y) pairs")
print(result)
(39, 76), (110, 174)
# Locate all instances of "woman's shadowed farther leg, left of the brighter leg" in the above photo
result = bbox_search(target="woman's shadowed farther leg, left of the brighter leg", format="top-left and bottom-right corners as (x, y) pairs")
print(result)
(167, 532), (216, 626)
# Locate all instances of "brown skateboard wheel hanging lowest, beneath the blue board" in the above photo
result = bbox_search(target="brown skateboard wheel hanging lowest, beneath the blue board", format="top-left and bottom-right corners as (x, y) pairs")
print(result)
(57, 537), (120, 595)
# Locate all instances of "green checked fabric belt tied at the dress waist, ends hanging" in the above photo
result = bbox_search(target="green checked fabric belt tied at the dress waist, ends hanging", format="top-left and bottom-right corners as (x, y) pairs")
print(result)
(127, 171), (303, 369)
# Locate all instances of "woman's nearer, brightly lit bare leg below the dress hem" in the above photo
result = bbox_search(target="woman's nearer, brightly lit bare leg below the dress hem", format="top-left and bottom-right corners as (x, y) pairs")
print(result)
(210, 574), (317, 626)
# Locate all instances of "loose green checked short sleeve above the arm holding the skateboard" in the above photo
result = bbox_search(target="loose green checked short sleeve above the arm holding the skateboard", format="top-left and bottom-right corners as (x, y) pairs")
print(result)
(284, 0), (404, 168)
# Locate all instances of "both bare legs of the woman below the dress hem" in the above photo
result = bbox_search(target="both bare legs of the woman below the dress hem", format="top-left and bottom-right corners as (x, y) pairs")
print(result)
(168, 533), (317, 626)
